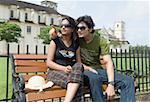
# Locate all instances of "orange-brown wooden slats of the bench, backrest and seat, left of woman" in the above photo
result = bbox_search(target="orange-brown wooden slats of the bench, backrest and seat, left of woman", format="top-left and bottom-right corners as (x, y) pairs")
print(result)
(11, 54), (66, 102)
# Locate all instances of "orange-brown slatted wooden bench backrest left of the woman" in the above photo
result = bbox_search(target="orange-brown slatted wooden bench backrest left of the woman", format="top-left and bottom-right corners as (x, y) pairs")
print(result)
(12, 54), (48, 81)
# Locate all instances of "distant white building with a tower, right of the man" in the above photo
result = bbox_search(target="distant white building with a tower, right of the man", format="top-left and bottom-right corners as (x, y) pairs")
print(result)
(99, 21), (129, 52)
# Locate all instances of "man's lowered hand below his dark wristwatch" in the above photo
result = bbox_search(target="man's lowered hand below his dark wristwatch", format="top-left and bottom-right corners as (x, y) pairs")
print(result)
(106, 84), (115, 100)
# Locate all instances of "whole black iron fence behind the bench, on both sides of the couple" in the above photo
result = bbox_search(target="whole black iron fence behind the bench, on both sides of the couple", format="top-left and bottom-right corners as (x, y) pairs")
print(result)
(0, 44), (150, 101)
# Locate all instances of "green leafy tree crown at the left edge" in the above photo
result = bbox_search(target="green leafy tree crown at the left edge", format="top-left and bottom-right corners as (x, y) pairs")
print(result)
(0, 23), (22, 43)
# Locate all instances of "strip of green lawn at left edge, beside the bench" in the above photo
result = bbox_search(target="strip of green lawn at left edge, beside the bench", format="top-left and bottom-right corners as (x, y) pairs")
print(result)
(0, 57), (12, 99)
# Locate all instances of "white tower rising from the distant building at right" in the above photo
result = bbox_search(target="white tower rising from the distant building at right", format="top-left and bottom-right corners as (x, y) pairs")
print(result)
(114, 21), (125, 40)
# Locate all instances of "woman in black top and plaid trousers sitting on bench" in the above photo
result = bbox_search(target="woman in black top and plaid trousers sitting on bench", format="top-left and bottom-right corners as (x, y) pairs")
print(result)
(47, 17), (84, 102)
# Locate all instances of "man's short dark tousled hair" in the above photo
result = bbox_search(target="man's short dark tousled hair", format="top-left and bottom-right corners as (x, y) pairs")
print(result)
(77, 15), (95, 33)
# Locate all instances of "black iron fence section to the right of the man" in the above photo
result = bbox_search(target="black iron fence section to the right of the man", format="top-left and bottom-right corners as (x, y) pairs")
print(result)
(111, 48), (150, 92)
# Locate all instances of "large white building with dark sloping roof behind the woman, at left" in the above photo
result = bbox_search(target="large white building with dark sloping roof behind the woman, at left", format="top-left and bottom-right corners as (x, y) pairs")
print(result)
(0, 0), (62, 54)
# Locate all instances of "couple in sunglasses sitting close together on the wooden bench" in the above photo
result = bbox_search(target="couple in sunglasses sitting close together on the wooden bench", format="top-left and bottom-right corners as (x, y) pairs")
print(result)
(47, 16), (135, 102)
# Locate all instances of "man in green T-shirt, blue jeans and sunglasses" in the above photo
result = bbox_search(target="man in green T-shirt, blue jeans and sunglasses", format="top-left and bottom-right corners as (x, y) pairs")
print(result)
(77, 16), (135, 102)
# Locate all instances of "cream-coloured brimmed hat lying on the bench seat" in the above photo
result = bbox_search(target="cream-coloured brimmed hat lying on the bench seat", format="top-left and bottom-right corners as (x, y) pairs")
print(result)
(25, 76), (54, 91)
